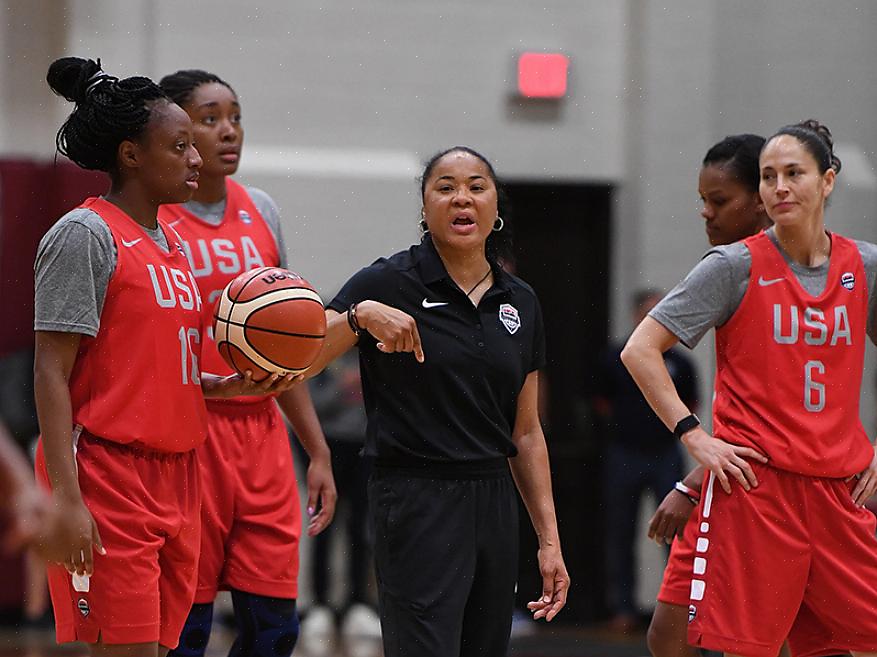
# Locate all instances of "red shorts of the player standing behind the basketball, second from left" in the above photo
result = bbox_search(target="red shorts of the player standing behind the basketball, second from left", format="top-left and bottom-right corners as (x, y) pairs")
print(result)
(195, 399), (301, 603)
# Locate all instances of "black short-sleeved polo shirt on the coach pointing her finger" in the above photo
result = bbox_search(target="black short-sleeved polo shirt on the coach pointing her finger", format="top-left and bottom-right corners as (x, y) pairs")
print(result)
(329, 237), (545, 462)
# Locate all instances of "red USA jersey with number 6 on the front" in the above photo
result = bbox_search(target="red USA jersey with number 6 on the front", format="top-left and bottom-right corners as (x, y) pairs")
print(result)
(713, 233), (874, 477)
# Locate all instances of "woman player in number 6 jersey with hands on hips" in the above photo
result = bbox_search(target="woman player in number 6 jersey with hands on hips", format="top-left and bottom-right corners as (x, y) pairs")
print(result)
(622, 120), (877, 657)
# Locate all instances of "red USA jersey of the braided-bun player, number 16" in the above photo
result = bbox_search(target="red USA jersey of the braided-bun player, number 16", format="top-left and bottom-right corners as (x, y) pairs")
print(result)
(70, 198), (207, 452)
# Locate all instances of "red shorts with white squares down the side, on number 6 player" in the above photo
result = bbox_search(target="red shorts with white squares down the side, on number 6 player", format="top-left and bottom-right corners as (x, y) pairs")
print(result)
(688, 461), (877, 657)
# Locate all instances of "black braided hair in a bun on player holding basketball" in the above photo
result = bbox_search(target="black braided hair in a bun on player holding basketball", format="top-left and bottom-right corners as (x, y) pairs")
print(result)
(46, 57), (168, 173)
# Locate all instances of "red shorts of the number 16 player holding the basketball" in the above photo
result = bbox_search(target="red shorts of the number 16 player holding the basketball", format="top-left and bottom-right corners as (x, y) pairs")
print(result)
(36, 432), (200, 648)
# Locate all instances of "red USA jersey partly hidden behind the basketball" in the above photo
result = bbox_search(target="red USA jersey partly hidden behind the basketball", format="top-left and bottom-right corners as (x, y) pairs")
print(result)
(158, 178), (280, 390)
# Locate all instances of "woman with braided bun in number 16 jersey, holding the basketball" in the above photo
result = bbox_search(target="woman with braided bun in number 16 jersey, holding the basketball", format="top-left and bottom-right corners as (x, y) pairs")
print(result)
(34, 57), (292, 657)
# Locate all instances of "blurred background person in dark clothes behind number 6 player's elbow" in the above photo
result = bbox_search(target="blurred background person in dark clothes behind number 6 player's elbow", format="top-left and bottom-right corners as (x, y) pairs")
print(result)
(594, 288), (698, 633)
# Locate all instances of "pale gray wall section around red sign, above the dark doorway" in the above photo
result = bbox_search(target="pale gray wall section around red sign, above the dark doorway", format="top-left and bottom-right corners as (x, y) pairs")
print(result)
(37, 0), (625, 291)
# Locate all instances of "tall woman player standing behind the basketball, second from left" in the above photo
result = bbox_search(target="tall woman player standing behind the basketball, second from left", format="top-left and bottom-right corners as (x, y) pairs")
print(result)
(158, 70), (335, 657)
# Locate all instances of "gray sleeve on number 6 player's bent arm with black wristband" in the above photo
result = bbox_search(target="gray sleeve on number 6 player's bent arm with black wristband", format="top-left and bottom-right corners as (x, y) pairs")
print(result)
(649, 243), (752, 349)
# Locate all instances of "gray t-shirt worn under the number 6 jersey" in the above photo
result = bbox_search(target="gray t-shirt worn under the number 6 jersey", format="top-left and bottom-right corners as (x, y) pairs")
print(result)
(649, 228), (877, 348)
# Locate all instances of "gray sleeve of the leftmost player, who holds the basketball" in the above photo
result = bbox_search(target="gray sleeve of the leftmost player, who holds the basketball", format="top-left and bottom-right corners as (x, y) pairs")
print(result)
(34, 208), (116, 337)
